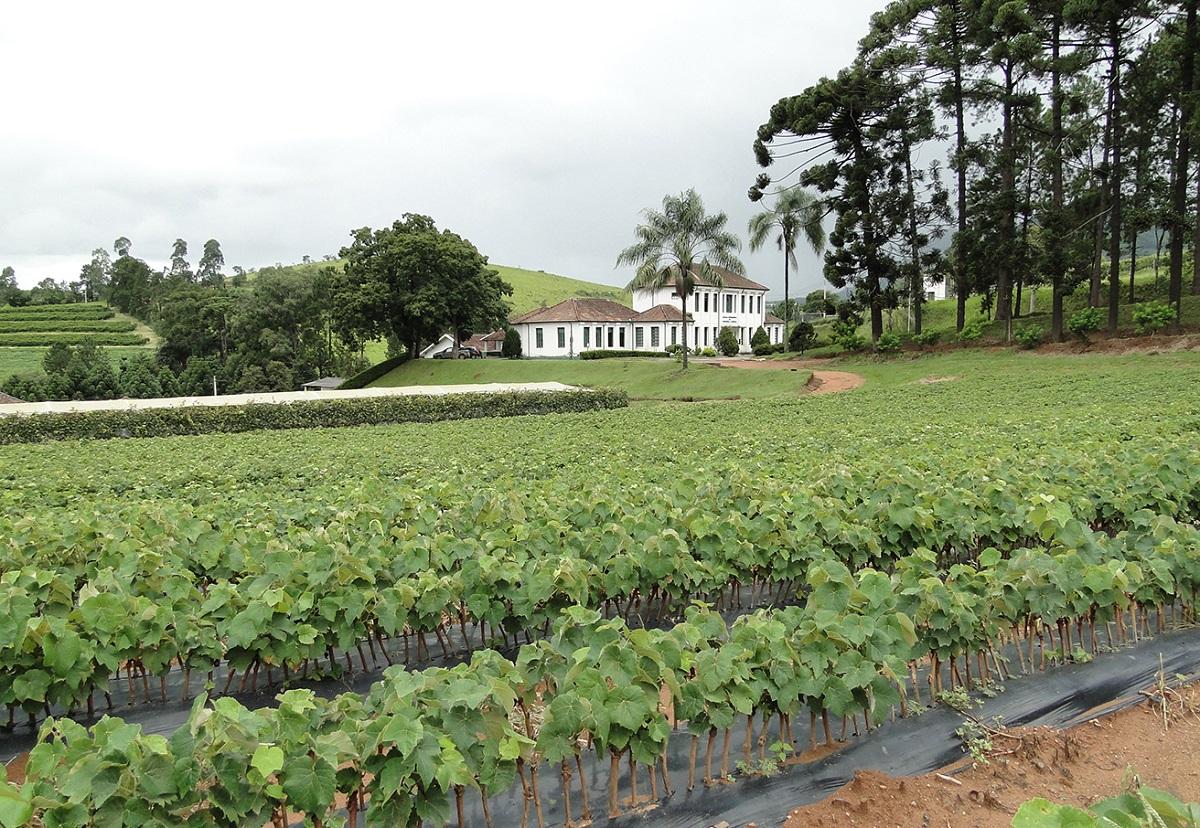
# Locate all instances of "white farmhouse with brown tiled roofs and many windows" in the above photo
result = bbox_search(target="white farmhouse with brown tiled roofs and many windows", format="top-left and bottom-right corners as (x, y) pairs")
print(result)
(511, 264), (784, 356)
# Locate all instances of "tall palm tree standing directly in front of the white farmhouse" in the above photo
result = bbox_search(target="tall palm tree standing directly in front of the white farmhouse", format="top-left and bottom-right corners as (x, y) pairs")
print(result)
(617, 190), (745, 371)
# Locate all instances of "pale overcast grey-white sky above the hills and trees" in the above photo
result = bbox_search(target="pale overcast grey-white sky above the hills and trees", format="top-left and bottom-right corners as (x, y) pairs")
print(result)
(0, 0), (883, 293)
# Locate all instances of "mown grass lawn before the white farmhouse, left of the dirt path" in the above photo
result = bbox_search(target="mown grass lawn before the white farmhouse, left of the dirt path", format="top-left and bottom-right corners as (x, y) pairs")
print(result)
(373, 359), (811, 400)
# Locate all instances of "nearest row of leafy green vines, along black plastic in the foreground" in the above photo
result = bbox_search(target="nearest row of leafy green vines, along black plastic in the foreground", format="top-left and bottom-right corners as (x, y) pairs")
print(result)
(4, 504), (1200, 826)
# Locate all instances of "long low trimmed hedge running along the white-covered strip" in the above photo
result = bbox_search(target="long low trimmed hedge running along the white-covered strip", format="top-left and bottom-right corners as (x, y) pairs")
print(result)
(0, 389), (629, 445)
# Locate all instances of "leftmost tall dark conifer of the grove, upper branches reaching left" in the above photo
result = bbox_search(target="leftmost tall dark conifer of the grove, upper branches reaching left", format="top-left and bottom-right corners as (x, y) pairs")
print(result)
(750, 53), (908, 340)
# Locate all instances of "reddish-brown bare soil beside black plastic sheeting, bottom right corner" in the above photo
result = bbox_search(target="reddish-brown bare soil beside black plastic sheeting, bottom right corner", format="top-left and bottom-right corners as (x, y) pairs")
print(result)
(784, 685), (1200, 828)
